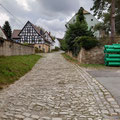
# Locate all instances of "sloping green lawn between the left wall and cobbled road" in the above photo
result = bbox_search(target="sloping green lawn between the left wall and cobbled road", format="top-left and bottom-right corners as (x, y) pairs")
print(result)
(0, 55), (41, 89)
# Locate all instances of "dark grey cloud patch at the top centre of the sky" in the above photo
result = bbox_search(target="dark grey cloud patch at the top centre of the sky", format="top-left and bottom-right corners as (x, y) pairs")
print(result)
(38, 0), (80, 14)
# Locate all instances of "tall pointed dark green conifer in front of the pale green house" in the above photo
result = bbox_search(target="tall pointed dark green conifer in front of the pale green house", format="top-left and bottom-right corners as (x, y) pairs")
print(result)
(64, 7), (93, 54)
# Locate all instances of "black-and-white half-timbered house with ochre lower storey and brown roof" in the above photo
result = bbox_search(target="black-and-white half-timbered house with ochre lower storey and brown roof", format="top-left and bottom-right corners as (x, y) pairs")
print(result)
(12, 21), (52, 52)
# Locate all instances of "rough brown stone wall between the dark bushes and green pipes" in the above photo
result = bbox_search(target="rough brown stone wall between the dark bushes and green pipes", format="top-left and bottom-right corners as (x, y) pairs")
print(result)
(67, 47), (104, 64)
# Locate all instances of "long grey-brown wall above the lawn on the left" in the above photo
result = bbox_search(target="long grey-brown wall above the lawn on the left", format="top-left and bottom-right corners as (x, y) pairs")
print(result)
(0, 38), (35, 56)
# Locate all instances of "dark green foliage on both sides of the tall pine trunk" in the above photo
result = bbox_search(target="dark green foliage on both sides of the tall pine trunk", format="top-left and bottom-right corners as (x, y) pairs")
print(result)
(91, 0), (120, 35)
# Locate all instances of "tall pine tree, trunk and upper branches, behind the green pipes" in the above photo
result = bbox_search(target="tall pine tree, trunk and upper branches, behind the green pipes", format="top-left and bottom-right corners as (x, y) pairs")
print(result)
(91, 0), (120, 43)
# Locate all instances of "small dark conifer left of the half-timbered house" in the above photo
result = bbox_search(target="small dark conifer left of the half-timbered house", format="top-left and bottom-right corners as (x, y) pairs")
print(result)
(3, 21), (12, 39)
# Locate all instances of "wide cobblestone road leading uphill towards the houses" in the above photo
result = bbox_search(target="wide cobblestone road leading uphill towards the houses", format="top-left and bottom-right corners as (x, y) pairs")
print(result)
(0, 53), (120, 120)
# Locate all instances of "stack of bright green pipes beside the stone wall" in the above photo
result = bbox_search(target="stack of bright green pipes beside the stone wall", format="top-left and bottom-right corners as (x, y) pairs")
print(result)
(104, 44), (120, 66)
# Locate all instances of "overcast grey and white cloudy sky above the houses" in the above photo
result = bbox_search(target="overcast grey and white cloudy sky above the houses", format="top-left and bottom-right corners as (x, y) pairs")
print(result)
(0, 0), (93, 38)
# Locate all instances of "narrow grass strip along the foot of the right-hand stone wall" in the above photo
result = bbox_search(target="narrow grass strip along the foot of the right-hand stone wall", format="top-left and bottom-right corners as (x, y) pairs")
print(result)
(62, 53), (106, 69)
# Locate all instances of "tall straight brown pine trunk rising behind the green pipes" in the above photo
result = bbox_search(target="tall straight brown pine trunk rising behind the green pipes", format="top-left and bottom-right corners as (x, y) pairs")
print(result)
(111, 0), (115, 44)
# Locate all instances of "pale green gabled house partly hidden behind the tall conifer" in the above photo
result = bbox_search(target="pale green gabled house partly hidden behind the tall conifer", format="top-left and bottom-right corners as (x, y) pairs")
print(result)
(65, 10), (101, 38)
